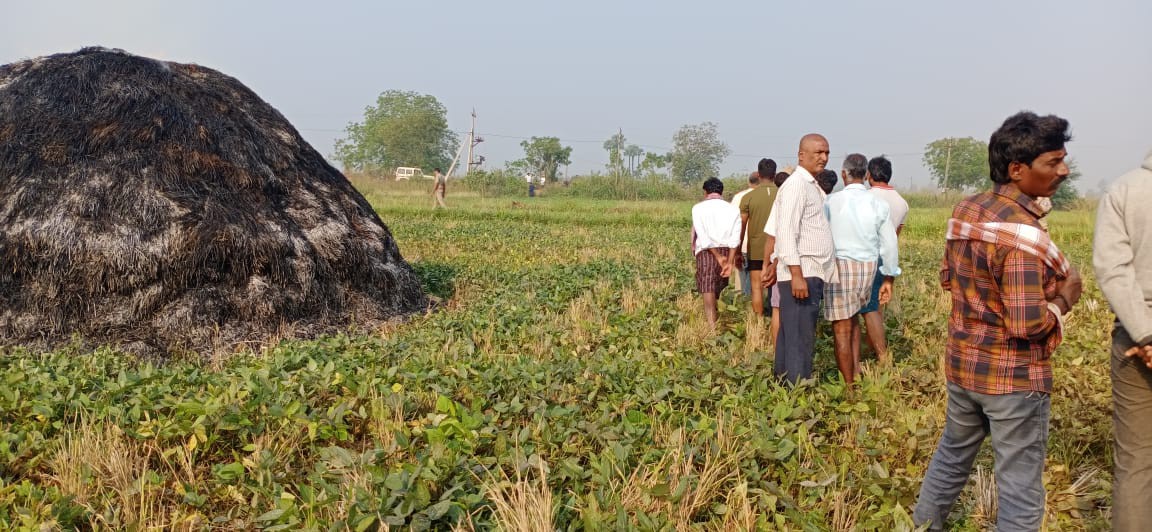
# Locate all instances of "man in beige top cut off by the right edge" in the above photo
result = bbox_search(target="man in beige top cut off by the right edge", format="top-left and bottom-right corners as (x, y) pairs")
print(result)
(1092, 146), (1152, 532)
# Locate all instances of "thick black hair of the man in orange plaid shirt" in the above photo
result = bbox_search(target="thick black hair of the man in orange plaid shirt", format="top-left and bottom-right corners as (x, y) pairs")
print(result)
(988, 111), (1073, 184)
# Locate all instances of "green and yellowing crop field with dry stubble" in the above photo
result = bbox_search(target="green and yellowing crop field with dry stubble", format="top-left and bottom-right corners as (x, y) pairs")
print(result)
(0, 182), (1112, 531)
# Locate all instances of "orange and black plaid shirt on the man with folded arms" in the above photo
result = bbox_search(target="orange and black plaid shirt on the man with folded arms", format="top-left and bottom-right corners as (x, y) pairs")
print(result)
(940, 184), (1061, 395)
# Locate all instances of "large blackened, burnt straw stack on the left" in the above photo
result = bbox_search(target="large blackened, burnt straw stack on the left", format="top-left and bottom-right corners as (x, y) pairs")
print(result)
(0, 48), (427, 354)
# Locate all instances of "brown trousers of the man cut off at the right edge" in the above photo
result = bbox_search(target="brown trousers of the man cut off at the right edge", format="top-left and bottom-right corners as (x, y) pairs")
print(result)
(1112, 327), (1152, 532)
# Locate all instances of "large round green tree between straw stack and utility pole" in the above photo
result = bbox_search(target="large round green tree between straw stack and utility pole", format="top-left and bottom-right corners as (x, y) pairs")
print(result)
(335, 90), (460, 170)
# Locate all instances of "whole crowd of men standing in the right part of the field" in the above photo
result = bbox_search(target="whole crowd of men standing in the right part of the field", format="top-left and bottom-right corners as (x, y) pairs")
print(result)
(692, 112), (1152, 531)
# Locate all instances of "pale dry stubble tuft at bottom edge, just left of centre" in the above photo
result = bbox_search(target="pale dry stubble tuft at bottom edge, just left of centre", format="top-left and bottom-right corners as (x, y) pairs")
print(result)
(484, 461), (555, 532)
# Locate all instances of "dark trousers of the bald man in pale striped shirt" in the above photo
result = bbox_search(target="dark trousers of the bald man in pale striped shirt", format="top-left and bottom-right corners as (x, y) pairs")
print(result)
(775, 278), (824, 385)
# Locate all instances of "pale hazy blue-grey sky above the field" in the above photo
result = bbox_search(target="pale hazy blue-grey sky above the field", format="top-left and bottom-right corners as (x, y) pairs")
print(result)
(0, 0), (1152, 191)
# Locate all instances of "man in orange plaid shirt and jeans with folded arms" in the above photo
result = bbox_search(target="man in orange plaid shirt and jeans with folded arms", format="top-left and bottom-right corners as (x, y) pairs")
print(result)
(912, 112), (1082, 532)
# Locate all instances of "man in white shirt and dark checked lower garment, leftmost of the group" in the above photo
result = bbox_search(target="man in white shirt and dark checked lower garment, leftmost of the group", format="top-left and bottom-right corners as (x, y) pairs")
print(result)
(692, 177), (741, 328)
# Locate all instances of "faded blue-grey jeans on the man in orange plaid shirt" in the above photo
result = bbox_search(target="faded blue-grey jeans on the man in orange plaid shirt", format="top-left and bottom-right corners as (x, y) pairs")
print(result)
(912, 382), (1052, 532)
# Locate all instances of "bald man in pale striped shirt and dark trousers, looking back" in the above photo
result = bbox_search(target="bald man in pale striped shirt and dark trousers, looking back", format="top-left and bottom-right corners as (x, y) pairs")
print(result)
(763, 134), (836, 383)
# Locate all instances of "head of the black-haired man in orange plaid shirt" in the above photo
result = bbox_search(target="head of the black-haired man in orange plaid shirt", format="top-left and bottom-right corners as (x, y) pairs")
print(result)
(988, 111), (1073, 198)
